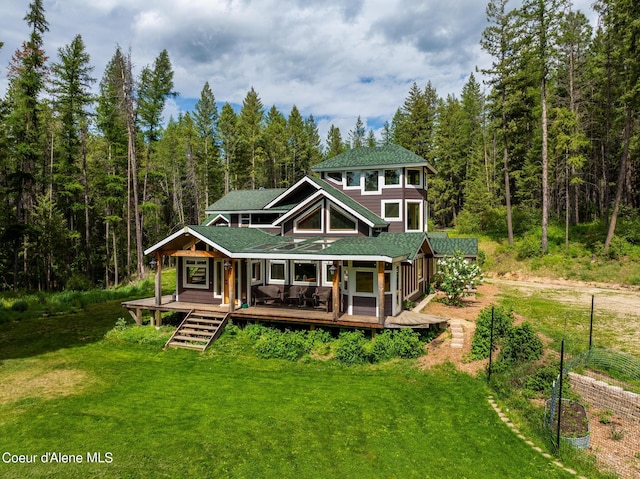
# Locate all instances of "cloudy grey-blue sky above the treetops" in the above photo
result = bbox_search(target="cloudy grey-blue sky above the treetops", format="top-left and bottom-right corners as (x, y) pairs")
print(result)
(0, 0), (595, 140)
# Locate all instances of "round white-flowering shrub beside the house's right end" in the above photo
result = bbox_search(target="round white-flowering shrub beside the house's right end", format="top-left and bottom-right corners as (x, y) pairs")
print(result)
(435, 251), (482, 304)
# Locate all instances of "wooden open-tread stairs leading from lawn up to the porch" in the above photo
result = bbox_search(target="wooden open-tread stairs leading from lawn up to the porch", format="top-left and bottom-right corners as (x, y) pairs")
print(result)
(164, 309), (229, 351)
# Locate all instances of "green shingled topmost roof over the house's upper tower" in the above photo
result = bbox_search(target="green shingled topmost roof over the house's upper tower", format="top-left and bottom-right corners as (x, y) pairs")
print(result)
(312, 145), (436, 173)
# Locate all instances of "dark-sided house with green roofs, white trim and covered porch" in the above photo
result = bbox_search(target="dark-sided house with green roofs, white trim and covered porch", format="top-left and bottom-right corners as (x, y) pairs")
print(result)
(125, 145), (477, 350)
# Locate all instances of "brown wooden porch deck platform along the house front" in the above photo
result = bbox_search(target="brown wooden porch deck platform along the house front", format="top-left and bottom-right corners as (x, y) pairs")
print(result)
(122, 296), (384, 329)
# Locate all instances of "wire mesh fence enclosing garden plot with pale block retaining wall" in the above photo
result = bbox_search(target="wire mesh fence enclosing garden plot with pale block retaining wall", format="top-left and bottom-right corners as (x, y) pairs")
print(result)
(545, 341), (640, 478)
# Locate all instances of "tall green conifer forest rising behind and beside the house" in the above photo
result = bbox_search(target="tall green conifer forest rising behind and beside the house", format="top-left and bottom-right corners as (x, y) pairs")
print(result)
(0, 0), (640, 290)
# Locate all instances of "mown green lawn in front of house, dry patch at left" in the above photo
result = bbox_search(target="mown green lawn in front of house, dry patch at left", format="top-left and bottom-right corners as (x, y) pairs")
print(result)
(0, 328), (570, 478)
